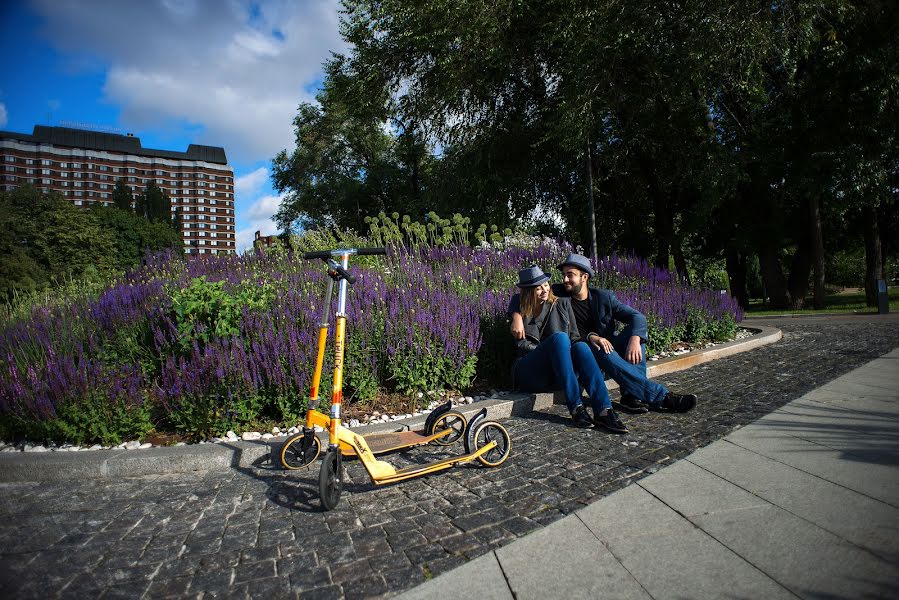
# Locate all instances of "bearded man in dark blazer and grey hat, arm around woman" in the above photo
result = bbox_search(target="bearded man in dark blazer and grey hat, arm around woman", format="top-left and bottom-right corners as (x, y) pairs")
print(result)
(509, 253), (696, 414)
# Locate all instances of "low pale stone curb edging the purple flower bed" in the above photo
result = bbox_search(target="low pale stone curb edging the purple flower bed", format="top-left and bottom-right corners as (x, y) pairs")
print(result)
(0, 325), (783, 482)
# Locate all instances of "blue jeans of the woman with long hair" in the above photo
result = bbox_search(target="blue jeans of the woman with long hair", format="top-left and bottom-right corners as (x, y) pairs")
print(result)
(514, 332), (612, 415)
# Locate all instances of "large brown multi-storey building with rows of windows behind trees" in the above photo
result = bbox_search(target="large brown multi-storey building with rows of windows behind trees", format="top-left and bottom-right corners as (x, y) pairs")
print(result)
(0, 125), (235, 254)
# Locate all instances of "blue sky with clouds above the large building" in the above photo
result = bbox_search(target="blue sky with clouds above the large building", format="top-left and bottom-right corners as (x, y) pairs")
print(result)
(0, 0), (347, 251)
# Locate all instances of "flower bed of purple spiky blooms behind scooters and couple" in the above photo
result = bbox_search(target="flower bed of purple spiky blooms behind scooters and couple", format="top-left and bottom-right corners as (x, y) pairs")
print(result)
(0, 240), (742, 444)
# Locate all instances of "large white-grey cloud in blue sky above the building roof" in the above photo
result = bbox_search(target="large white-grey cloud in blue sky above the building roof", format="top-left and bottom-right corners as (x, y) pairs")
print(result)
(33, 0), (346, 162)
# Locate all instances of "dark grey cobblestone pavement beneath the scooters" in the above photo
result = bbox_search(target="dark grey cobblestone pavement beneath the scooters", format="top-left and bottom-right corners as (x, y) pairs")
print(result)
(0, 316), (899, 599)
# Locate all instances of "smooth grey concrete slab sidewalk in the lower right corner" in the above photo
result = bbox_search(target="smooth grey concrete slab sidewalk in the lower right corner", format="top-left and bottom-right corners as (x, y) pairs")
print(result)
(399, 349), (899, 600)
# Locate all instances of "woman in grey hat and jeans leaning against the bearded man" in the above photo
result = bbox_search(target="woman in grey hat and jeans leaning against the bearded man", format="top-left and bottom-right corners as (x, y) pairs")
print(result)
(512, 265), (627, 433)
